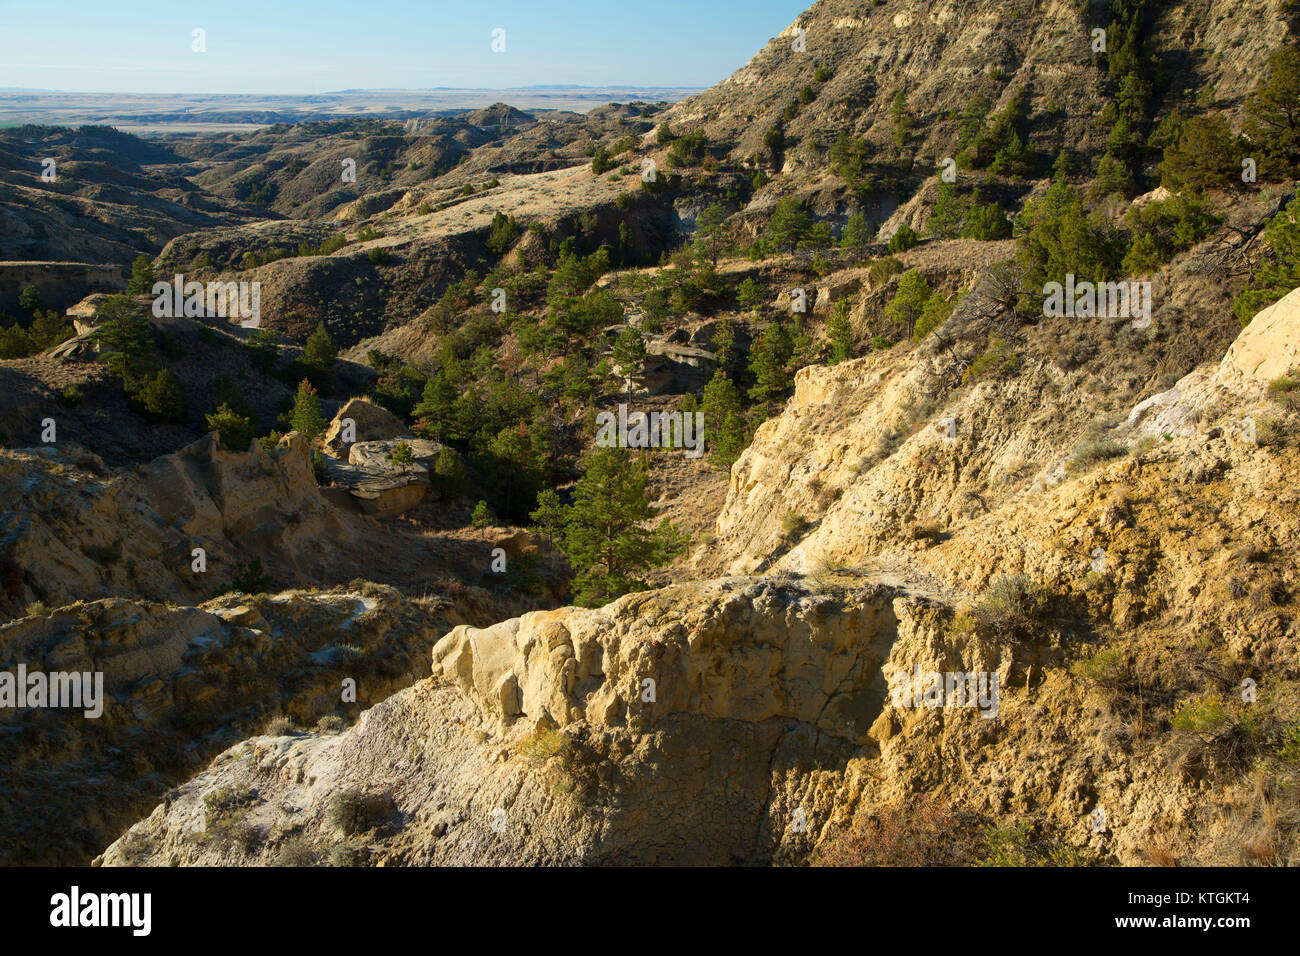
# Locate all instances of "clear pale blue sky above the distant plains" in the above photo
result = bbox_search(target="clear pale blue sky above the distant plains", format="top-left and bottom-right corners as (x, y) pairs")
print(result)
(0, 0), (813, 94)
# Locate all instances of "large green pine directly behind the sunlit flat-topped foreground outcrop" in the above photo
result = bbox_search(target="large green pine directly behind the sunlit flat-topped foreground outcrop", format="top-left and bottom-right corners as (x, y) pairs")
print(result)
(560, 447), (685, 607)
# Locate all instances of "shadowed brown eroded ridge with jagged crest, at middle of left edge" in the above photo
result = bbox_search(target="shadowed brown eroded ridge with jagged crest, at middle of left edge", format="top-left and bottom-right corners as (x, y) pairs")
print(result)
(0, 432), (360, 614)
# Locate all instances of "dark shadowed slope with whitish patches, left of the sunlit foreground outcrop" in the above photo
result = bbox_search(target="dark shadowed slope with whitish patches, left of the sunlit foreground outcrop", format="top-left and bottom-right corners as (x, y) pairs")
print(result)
(0, 584), (456, 866)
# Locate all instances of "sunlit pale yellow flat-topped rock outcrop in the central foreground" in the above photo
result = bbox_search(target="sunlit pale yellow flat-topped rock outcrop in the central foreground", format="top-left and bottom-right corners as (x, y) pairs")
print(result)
(103, 579), (980, 865)
